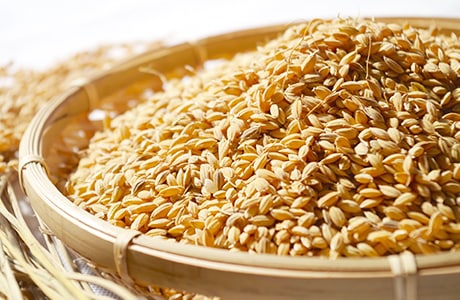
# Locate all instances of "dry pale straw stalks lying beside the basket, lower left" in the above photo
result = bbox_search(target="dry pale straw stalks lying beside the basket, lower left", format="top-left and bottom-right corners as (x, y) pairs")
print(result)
(0, 173), (144, 299)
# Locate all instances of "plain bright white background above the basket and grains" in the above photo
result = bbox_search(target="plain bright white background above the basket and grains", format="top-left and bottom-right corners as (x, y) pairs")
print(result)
(0, 0), (460, 68)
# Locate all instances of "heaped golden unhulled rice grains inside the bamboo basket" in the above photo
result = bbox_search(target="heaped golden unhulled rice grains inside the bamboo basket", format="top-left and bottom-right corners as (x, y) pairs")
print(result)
(66, 19), (460, 258)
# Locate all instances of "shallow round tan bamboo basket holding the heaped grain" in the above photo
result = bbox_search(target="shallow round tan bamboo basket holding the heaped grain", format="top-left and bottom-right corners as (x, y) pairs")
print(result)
(19, 18), (460, 300)
